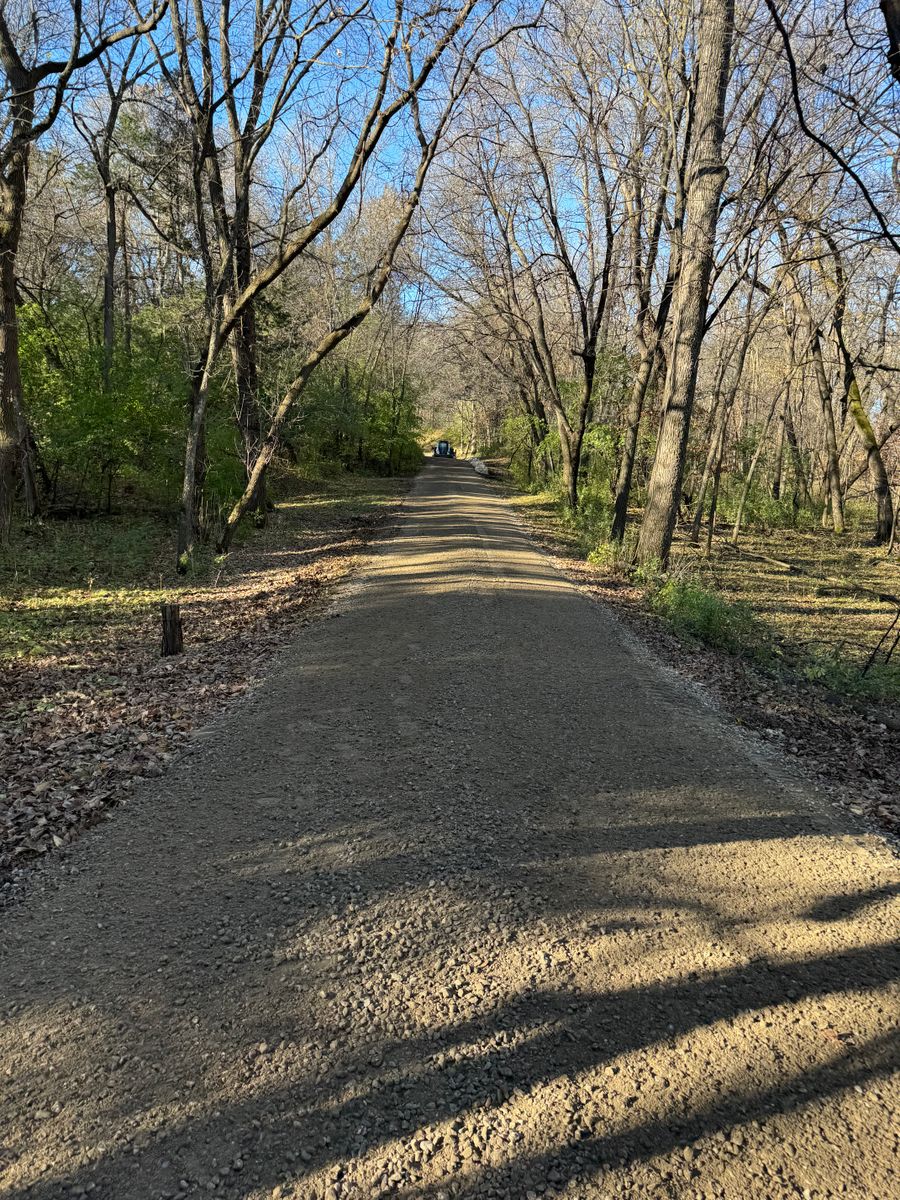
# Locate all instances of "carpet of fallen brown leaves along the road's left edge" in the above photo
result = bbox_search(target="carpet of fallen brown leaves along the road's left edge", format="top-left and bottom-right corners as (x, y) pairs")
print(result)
(0, 487), (408, 887)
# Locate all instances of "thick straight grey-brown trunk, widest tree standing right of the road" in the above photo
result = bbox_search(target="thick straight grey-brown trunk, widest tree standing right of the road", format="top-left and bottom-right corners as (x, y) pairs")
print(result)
(637, 0), (734, 566)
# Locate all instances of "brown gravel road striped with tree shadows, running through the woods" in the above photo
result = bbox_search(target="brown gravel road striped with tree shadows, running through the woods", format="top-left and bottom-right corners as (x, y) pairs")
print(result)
(0, 461), (900, 1200)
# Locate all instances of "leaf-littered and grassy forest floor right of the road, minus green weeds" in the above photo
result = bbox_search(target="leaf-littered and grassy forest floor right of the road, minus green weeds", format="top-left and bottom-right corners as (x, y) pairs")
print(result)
(499, 482), (900, 835)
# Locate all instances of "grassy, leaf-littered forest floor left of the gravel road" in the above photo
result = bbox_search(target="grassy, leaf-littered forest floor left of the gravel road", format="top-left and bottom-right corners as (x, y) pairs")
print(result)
(0, 475), (409, 895)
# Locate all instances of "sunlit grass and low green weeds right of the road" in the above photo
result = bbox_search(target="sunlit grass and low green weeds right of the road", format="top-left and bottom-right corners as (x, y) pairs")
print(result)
(501, 475), (900, 704)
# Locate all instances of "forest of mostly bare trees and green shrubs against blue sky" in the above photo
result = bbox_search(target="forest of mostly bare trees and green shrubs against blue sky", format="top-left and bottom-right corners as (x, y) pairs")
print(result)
(0, 0), (900, 696)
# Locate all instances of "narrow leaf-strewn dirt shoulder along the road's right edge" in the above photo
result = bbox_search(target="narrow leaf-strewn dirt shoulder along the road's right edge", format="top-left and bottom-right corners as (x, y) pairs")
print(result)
(492, 480), (900, 839)
